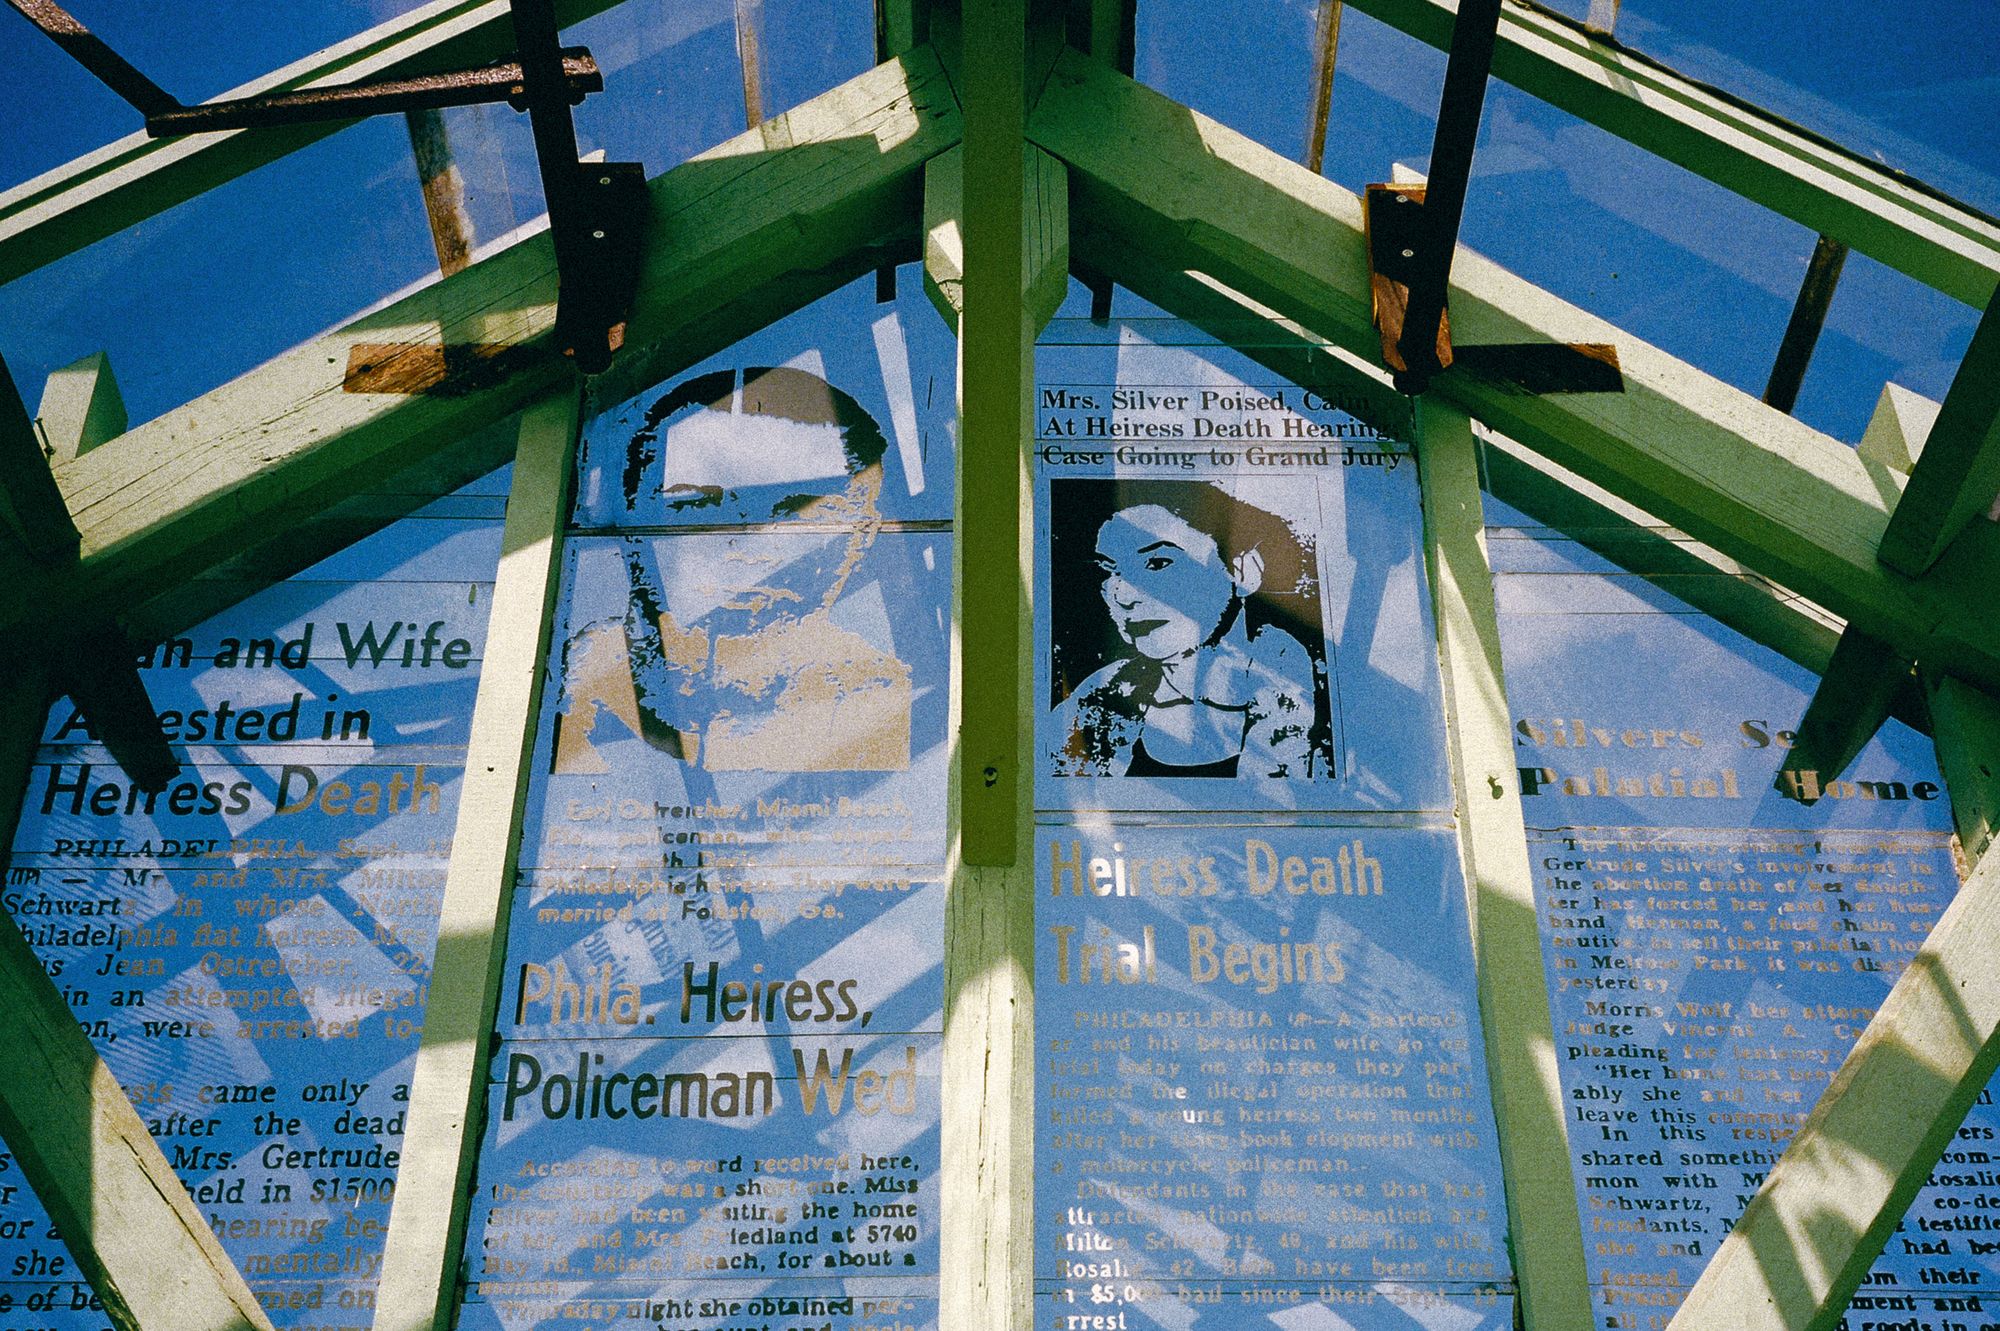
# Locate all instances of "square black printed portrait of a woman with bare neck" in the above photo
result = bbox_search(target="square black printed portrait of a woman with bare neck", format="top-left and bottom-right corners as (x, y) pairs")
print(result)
(1048, 478), (1334, 779)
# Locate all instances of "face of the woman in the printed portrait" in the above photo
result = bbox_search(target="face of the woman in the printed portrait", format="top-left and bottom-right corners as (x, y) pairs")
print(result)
(1098, 504), (1236, 662)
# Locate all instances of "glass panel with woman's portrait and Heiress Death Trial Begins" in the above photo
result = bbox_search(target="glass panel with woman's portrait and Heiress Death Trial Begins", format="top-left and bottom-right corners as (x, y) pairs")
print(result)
(1034, 320), (1514, 1331)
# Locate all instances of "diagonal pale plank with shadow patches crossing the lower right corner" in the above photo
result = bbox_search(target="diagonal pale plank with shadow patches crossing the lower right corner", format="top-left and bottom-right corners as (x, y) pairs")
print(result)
(1670, 815), (2000, 1331)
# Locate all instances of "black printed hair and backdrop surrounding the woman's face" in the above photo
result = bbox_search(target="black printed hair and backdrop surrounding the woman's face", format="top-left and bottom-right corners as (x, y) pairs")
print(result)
(1048, 478), (1332, 767)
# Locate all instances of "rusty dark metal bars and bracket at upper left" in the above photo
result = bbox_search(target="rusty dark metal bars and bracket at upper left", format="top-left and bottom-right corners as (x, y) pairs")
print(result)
(6, 0), (650, 374)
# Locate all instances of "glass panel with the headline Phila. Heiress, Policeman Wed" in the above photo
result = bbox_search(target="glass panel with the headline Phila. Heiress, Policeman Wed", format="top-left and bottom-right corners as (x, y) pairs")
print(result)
(462, 268), (956, 1327)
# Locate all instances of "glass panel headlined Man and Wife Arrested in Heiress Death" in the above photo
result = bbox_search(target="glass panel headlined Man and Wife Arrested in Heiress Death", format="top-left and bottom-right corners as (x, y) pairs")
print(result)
(0, 463), (506, 1327)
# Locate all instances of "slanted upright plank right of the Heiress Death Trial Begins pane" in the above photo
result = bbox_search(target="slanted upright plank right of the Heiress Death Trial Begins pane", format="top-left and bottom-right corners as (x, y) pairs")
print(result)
(1416, 402), (1596, 1327)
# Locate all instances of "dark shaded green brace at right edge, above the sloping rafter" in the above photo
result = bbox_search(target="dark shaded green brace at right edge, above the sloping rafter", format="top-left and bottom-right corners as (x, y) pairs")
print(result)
(1882, 300), (2000, 578)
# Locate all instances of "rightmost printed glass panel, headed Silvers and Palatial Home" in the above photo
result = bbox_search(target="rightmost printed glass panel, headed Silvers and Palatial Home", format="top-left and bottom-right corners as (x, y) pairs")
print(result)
(1488, 461), (2000, 1329)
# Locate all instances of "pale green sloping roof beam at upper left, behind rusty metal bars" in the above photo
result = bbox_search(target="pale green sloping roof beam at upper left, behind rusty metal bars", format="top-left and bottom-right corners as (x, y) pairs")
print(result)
(0, 0), (618, 282)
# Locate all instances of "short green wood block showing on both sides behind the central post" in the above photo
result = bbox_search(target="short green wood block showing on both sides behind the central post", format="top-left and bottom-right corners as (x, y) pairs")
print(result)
(924, 144), (1070, 332)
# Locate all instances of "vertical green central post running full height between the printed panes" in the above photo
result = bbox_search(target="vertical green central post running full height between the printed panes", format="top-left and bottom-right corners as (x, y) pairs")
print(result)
(930, 0), (1034, 1329)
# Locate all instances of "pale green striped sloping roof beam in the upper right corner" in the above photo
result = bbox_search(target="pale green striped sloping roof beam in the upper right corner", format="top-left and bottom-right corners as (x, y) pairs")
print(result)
(1350, 0), (2000, 305)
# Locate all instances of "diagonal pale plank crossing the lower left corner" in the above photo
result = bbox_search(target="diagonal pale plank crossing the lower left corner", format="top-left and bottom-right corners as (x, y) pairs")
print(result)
(0, 644), (270, 1331)
